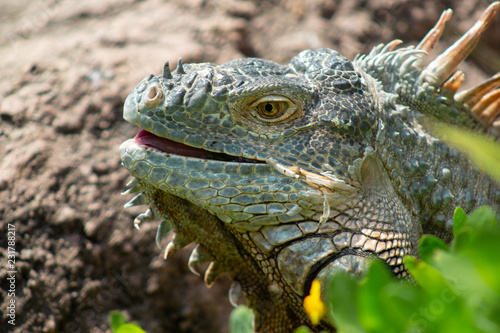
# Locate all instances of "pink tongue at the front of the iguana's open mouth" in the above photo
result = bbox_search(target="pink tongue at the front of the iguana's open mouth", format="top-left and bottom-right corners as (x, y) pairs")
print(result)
(134, 130), (207, 158)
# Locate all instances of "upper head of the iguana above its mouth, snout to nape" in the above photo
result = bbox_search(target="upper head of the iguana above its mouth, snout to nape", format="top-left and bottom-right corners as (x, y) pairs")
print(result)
(124, 49), (378, 184)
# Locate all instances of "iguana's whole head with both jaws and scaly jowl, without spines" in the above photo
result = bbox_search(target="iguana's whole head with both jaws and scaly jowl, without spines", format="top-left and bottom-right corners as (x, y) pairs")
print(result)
(121, 49), (414, 330)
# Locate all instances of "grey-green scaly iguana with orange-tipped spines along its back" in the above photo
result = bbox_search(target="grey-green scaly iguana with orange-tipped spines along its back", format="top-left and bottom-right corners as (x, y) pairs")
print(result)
(120, 2), (500, 332)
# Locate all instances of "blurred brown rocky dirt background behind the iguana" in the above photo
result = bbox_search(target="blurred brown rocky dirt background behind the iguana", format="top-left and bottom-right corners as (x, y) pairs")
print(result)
(0, 0), (500, 333)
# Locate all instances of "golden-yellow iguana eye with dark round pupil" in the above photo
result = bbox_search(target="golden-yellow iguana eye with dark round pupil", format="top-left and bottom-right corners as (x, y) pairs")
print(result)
(249, 95), (297, 122)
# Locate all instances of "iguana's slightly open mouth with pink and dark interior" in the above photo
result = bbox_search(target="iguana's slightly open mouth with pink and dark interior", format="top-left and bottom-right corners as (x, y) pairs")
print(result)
(134, 130), (265, 163)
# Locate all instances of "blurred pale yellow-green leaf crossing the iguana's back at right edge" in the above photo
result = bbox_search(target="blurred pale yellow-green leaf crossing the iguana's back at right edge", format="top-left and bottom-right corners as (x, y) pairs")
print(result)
(435, 123), (500, 181)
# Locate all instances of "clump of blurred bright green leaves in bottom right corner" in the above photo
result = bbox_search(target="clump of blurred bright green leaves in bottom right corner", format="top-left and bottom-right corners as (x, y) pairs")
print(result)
(327, 207), (500, 333)
